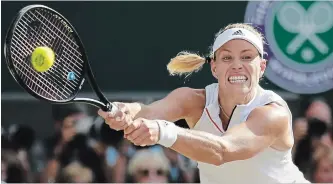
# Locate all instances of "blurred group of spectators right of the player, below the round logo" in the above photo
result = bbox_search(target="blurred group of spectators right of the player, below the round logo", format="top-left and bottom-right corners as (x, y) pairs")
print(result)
(293, 99), (333, 183)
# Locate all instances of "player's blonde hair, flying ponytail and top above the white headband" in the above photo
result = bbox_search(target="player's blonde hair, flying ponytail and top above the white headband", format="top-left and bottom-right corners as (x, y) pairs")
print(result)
(167, 23), (264, 76)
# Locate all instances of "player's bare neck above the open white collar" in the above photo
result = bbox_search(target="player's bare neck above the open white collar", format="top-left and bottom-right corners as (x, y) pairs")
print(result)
(219, 90), (256, 116)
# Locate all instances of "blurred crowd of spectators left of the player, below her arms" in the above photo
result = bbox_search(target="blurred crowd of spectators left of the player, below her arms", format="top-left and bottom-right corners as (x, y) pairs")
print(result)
(1, 104), (199, 183)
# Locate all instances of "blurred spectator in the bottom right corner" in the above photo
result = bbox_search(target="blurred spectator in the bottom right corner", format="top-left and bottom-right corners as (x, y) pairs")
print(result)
(310, 144), (333, 183)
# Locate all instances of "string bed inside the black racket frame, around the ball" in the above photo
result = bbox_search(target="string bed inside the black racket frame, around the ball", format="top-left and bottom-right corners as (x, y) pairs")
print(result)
(11, 10), (84, 100)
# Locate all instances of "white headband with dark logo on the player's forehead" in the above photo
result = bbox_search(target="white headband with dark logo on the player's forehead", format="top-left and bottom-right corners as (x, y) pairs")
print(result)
(213, 28), (264, 56)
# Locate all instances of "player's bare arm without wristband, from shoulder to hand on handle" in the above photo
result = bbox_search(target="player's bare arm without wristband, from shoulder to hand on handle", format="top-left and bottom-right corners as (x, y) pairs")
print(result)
(98, 87), (205, 130)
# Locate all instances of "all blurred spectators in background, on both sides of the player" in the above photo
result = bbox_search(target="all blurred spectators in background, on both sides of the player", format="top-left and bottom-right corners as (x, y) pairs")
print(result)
(1, 99), (333, 183)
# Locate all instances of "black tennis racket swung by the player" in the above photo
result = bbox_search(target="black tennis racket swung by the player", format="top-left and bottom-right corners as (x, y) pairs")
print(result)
(4, 5), (117, 111)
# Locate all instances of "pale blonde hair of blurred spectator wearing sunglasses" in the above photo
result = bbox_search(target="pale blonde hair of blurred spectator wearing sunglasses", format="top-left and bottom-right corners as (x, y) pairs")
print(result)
(128, 149), (170, 175)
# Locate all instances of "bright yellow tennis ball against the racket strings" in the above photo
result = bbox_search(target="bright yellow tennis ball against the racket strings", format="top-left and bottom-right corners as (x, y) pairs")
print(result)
(31, 47), (55, 72)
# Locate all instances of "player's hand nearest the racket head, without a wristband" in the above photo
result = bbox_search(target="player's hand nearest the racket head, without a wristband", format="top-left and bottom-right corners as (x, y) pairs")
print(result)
(98, 102), (133, 131)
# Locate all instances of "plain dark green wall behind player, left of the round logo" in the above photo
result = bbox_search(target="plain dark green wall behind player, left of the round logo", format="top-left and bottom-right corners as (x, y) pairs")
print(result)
(1, 1), (282, 92)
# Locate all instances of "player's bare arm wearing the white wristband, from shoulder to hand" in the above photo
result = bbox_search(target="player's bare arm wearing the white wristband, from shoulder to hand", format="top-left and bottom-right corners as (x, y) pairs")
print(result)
(127, 105), (289, 165)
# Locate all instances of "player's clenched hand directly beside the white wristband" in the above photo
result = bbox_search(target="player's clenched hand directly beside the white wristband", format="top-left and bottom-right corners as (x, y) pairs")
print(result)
(124, 118), (159, 146)
